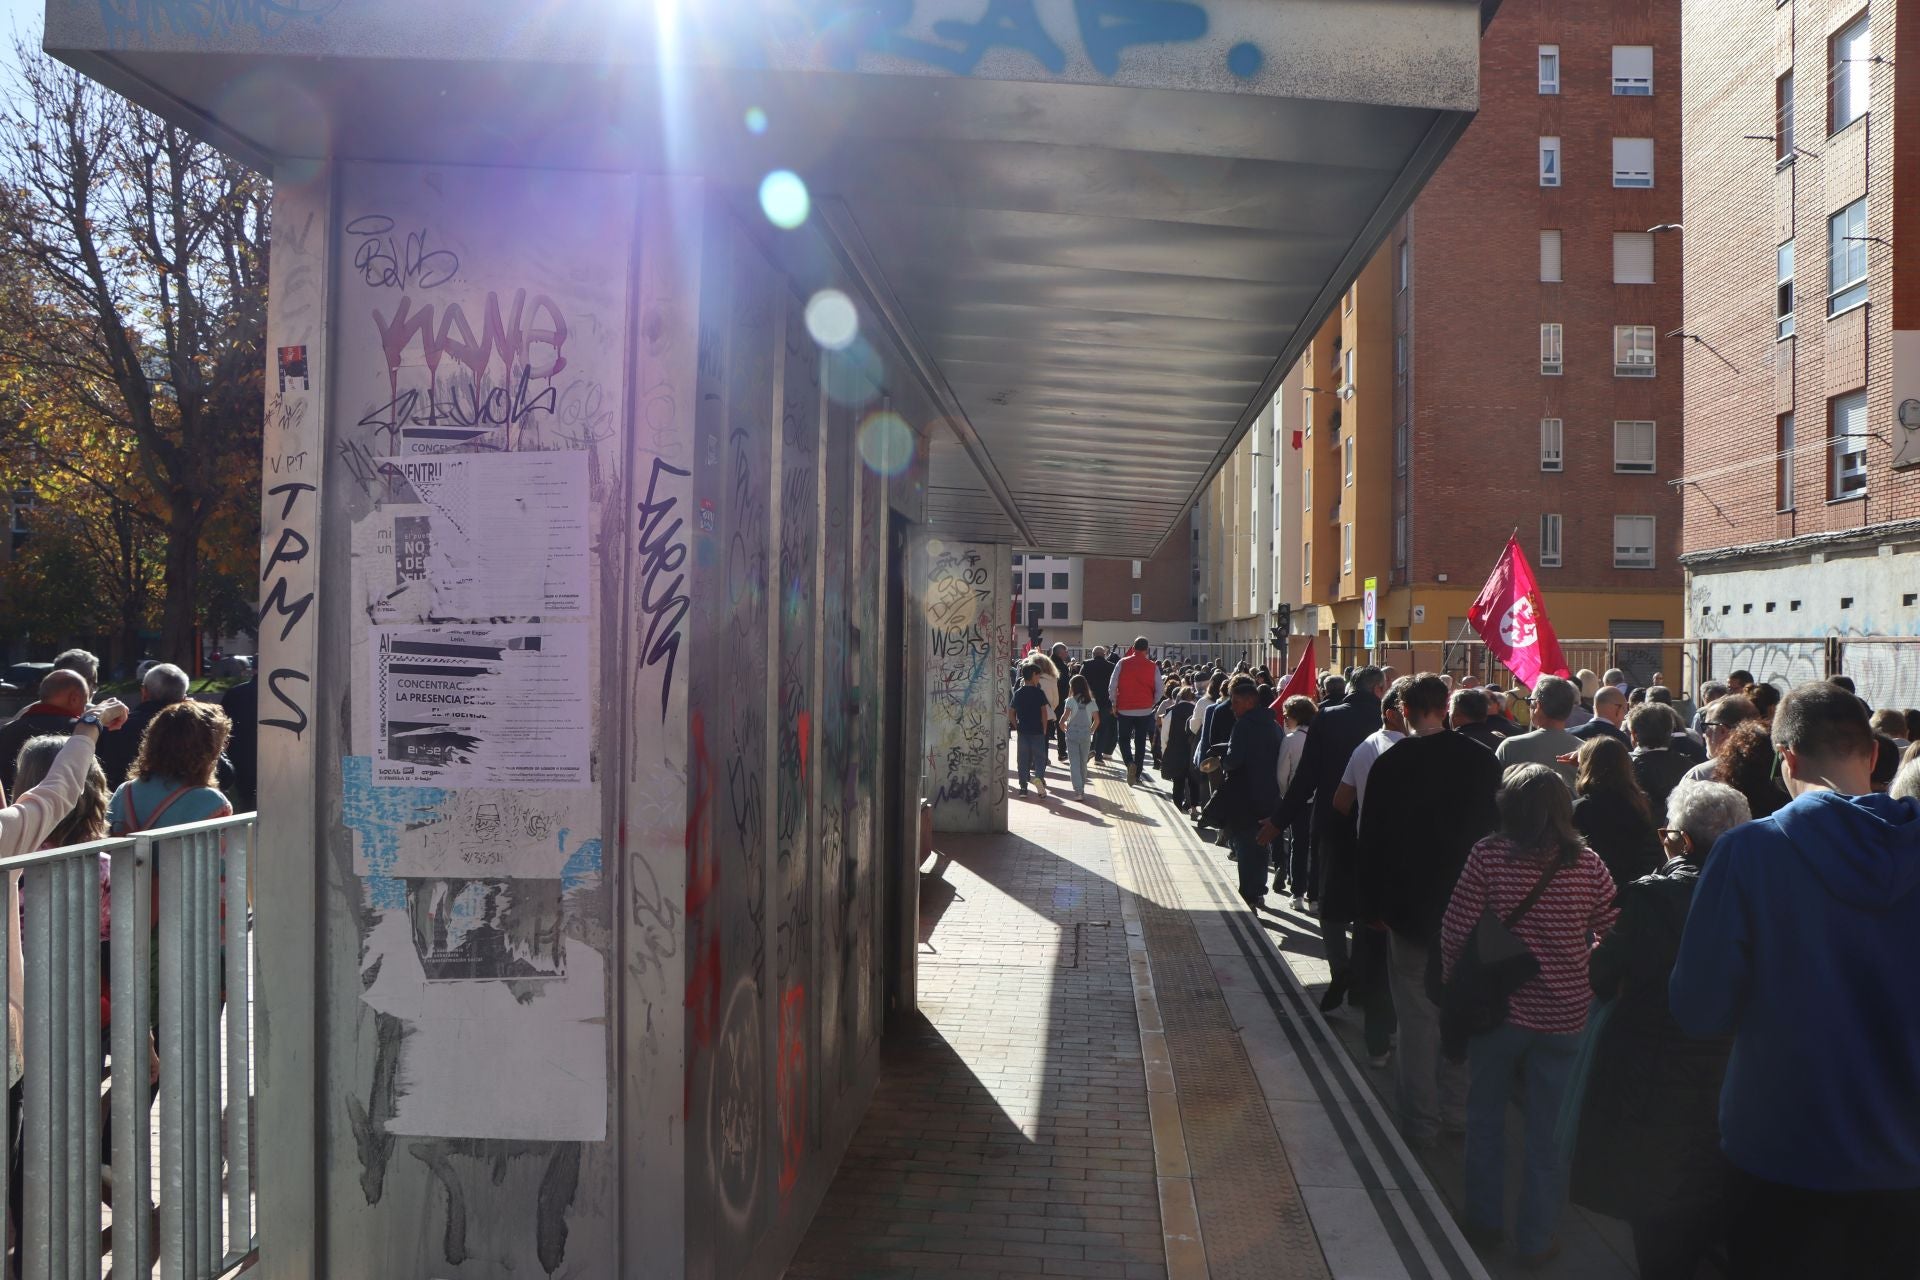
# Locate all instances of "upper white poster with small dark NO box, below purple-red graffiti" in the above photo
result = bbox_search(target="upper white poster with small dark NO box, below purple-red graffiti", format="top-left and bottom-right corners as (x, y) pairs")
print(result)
(355, 451), (591, 622)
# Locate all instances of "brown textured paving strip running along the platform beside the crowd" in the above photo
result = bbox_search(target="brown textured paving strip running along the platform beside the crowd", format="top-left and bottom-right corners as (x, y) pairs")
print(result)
(1100, 779), (1329, 1280)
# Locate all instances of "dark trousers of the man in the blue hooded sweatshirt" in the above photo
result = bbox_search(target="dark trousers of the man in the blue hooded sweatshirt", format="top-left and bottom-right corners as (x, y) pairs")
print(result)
(1726, 1169), (1920, 1280)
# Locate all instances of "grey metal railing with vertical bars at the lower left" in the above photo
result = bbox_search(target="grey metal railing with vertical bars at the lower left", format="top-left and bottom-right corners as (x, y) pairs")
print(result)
(0, 814), (257, 1280)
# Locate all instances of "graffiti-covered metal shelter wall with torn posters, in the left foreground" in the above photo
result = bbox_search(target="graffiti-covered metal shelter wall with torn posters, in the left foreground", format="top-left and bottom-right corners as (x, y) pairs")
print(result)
(259, 165), (929, 1280)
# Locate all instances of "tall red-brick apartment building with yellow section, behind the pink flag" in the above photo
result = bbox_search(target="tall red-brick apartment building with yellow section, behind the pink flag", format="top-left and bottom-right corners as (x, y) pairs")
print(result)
(1298, 0), (1699, 677)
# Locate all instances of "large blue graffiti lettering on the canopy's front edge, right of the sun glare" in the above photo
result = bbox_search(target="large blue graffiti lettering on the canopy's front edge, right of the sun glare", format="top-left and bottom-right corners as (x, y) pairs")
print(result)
(814, 0), (1208, 75)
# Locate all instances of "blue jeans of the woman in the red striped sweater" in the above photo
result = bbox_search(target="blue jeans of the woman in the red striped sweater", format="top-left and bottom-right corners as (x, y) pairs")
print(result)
(1467, 1023), (1580, 1253)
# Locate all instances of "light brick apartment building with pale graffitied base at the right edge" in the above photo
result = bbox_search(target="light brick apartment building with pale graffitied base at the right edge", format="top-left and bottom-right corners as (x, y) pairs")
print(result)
(1682, 0), (1920, 690)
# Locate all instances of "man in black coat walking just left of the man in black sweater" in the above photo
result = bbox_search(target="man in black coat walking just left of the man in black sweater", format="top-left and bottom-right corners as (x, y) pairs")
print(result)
(1260, 666), (1392, 1019)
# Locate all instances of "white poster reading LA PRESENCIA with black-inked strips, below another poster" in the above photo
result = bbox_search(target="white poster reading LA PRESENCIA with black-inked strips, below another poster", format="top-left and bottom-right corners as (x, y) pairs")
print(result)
(369, 622), (593, 787)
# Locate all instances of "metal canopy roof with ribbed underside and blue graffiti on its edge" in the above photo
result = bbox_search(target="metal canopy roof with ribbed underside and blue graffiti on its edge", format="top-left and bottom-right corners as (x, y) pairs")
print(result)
(46, 0), (1498, 557)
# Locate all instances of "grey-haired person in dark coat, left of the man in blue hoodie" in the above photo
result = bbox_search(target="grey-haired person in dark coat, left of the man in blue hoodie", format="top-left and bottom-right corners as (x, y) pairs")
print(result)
(1572, 781), (1749, 1280)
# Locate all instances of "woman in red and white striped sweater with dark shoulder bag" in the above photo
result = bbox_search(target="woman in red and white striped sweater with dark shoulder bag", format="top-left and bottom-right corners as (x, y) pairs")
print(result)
(1440, 764), (1619, 1267)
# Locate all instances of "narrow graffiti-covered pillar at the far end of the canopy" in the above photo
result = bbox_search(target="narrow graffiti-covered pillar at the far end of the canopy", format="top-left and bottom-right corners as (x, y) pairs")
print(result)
(918, 535), (1014, 831)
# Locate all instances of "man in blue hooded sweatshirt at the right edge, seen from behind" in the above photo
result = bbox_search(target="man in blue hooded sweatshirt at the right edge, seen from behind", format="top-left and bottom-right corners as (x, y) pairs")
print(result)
(1668, 683), (1920, 1280)
